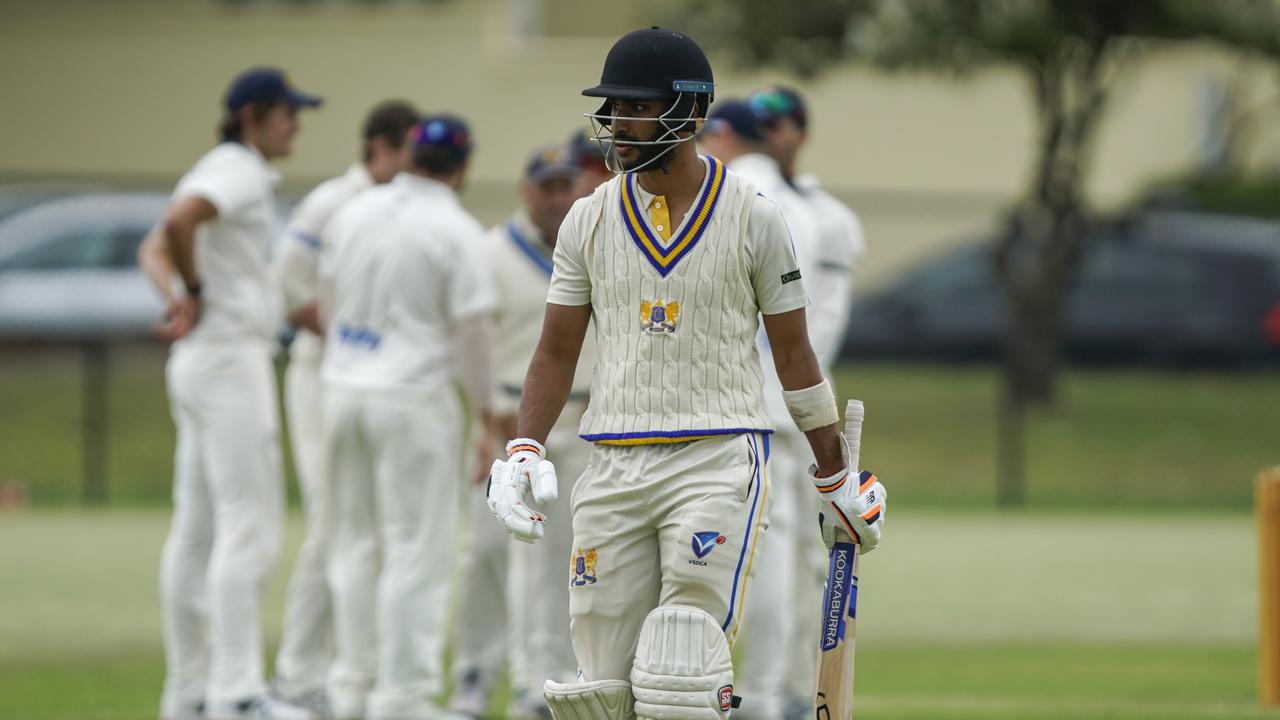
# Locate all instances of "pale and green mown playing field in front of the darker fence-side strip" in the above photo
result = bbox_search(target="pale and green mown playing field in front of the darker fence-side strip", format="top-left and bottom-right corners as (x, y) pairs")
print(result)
(0, 510), (1264, 720)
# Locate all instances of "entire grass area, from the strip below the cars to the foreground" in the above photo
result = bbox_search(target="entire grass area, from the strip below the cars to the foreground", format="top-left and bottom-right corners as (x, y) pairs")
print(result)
(0, 347), (1280, 720)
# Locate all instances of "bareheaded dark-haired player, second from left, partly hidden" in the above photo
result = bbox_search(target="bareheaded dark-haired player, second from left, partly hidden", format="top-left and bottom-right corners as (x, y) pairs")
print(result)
(273, 100), (419, 710)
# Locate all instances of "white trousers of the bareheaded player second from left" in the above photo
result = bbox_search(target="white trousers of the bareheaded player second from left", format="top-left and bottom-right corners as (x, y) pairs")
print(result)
(275, 357), (333, 697)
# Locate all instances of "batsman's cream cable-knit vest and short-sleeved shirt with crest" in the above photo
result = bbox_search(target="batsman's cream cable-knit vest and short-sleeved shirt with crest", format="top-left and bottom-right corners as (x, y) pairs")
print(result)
(547, 158), (808, 445)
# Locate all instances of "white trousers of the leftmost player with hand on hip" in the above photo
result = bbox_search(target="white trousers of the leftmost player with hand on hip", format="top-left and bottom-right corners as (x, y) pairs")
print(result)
(160, 340), (284, 715)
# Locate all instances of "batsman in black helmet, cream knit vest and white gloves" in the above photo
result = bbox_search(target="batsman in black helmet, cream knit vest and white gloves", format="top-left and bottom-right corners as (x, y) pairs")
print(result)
(489, 28), (883, 720)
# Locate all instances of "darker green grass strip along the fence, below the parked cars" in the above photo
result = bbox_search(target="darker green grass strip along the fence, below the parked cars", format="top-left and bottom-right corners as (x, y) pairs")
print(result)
(0, 346), (1280, 512)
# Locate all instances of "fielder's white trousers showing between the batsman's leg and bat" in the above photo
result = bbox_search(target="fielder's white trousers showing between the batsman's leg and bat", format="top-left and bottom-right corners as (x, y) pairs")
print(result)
(733, 425), (827, 720)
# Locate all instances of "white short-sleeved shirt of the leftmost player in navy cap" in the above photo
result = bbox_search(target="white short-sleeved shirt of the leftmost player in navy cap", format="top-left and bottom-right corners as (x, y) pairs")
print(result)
(173, 142), (284, 342)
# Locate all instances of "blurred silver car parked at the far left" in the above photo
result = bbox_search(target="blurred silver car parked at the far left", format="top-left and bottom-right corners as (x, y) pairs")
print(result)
(0, 193), (168, 338)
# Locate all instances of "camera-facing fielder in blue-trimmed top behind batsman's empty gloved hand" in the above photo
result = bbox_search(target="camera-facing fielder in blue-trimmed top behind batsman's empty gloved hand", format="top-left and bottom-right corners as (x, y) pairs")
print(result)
(449, 146), (591, 720)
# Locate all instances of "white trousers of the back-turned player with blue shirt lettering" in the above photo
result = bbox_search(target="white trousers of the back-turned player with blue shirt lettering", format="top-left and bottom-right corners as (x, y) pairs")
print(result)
(324, 383), (463, 720)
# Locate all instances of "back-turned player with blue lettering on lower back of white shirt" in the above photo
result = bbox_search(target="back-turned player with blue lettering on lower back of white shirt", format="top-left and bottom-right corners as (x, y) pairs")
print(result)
(320, 115), (494, 720)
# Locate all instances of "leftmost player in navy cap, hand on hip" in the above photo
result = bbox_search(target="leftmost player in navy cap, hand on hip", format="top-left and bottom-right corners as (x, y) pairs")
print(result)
(138, 68), (320, 720)
